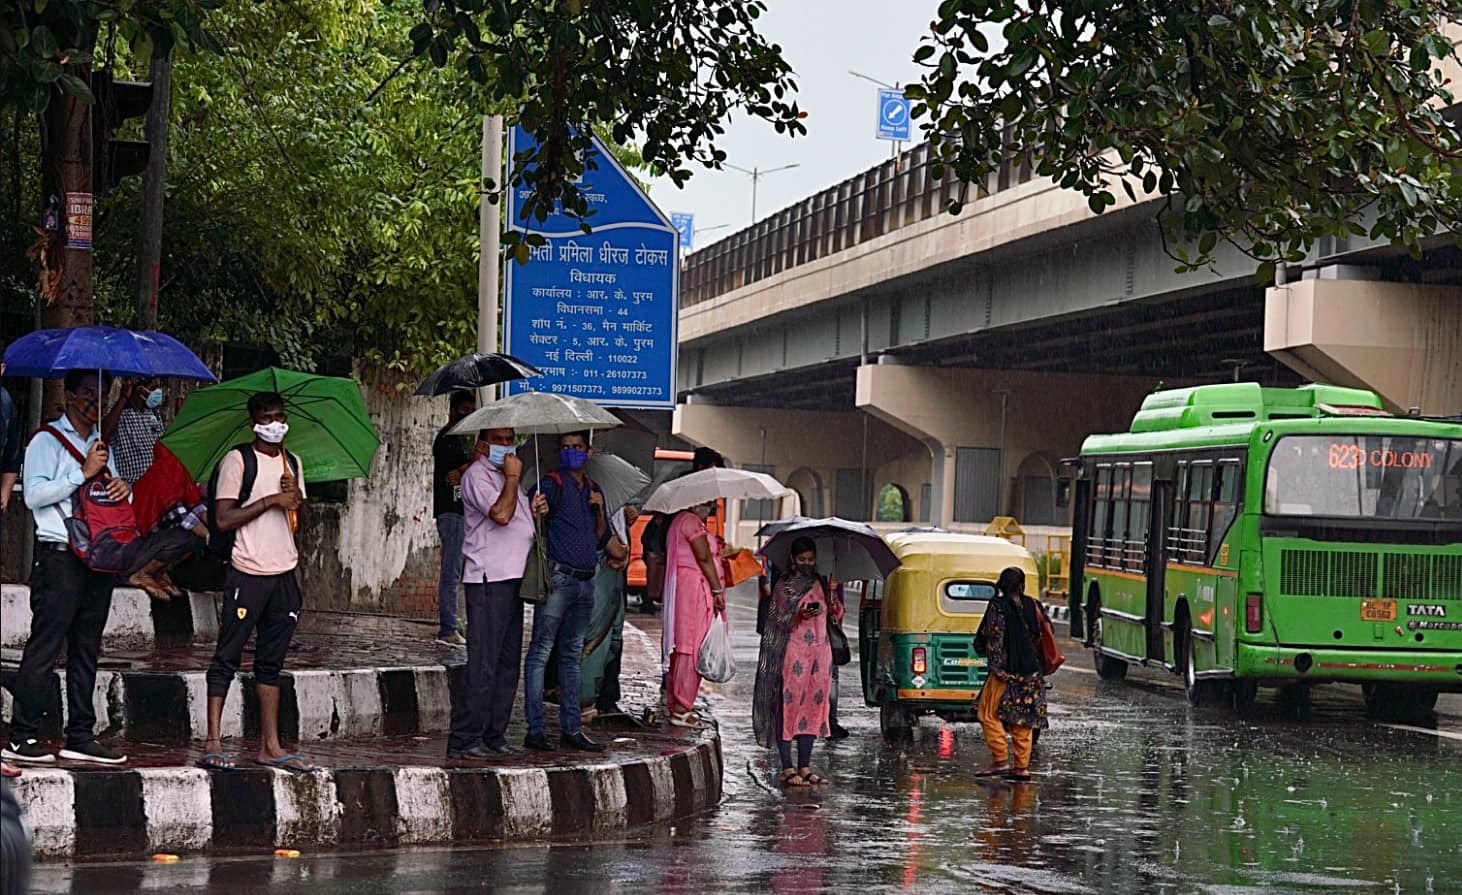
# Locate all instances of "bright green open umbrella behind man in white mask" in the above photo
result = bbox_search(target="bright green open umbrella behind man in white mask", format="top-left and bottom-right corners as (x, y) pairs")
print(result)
(162, 367), (380, 486)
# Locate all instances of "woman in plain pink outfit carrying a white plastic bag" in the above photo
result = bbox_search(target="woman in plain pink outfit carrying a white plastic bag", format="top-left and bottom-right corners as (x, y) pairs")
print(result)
(661, 503), (727, 730)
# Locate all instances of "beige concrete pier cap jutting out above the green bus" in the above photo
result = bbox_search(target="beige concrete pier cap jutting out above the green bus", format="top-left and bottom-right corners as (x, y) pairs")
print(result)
(1265, 276), (1462, 415)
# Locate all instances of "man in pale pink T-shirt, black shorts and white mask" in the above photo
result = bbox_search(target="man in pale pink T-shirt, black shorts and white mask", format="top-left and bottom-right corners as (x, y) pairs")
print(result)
(199, 392), (314, 774)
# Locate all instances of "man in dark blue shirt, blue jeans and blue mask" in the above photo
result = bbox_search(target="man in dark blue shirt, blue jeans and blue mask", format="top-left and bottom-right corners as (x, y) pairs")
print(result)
(523, 431), (610, 752)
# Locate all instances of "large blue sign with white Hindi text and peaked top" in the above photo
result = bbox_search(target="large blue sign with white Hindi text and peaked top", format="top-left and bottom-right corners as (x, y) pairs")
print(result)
(503, 127), (680, 408)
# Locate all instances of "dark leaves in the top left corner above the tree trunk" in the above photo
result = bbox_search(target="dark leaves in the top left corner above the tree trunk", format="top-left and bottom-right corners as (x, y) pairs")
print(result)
(0, 0), (224, 113)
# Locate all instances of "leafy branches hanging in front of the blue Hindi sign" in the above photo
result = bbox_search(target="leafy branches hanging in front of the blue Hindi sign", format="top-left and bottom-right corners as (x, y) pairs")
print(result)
(386, 0), (806, 260)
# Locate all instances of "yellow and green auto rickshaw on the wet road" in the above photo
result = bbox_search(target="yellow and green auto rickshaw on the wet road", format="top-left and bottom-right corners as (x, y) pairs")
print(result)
(858, 531), (1038, 739)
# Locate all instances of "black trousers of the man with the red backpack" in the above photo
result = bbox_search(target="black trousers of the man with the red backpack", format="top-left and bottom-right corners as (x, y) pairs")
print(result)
(10, 544), (115, 746)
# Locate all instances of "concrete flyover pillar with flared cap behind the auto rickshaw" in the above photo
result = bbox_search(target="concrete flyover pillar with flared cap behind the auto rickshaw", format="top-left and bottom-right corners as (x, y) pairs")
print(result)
(857, 364), (1156, 526)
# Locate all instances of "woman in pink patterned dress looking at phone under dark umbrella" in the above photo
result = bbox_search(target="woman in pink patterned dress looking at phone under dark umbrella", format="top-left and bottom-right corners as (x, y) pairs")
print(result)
(751, 538), (832, 787)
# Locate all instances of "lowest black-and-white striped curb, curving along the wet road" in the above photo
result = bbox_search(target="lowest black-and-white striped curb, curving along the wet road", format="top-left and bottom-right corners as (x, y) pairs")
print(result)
(15, 734), (722, 860)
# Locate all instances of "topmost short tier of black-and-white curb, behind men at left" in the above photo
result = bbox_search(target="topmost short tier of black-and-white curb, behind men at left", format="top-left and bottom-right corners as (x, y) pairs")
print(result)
(0, 585), (218, 651)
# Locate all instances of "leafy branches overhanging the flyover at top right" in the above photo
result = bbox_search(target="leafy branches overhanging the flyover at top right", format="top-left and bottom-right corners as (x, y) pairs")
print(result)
(908, 0), (1462, 268)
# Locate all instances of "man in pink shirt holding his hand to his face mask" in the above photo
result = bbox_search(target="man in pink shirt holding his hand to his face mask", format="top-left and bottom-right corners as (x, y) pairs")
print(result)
(447, 428), (544, 760)
